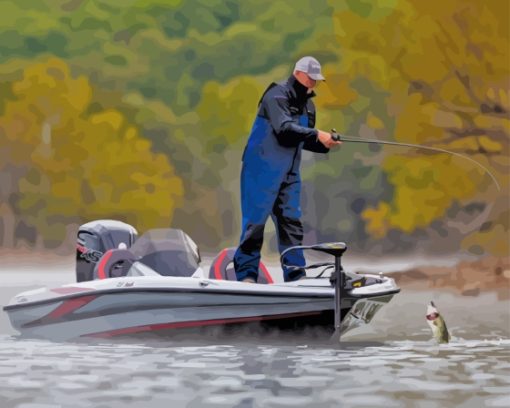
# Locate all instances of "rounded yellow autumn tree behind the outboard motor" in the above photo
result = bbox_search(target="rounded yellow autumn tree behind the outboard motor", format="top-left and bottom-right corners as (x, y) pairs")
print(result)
(2, 58), (183, 244)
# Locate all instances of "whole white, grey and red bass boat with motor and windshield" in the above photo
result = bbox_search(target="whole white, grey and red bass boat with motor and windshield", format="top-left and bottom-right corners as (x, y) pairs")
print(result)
(3, 220), (400, 341)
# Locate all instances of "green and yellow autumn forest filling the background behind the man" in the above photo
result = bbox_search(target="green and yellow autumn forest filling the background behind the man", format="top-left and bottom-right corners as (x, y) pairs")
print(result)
(0, 0), (504, 253)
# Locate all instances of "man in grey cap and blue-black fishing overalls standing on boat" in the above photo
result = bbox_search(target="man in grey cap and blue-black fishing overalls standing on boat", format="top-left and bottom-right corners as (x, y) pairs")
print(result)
(234, 57), (341, 282)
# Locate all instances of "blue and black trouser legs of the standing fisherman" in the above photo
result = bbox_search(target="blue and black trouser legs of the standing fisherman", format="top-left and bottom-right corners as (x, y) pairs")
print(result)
(234, 167), (305, 282)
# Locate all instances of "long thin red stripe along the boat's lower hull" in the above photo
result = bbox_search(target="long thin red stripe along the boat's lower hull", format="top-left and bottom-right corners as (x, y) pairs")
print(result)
(85, 311), (321, 337)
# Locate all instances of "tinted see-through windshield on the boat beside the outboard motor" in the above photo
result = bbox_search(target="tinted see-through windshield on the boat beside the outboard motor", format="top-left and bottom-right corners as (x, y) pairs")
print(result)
(130, 228), (200, 276)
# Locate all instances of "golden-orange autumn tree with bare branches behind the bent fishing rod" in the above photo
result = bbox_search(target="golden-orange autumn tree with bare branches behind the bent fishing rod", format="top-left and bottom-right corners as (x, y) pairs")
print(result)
(328, 0), (510, 253)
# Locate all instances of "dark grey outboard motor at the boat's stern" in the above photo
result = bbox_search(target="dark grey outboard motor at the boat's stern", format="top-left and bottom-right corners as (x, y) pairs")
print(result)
(76, 220), (137, 282)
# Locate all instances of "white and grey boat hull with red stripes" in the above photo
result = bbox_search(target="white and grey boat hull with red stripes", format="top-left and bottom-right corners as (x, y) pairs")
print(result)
(4, 276), (399, 341)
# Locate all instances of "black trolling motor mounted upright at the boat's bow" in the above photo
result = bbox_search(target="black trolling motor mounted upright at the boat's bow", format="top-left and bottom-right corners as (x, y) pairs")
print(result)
(280, 242), (363, 339)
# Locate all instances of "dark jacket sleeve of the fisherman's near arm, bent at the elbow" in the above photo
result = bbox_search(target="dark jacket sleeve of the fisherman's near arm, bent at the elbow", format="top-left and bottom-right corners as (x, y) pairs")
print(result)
(262, 87), (317, 147)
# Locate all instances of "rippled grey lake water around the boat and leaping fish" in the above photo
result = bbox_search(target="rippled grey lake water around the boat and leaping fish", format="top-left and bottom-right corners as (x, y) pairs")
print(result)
(0, 265), (510, 408)
